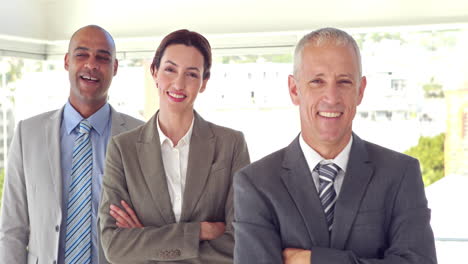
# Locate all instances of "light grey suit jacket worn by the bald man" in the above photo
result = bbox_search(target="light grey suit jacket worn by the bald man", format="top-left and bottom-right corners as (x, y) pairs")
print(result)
(0, 105), (143, 264)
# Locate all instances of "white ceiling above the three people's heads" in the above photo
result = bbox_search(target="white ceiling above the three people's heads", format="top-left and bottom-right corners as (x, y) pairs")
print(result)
(0, 0), (468, 58)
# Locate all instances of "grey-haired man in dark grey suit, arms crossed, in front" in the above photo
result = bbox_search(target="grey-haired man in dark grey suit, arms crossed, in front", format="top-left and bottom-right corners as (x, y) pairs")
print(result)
(234, 28), (437, 264)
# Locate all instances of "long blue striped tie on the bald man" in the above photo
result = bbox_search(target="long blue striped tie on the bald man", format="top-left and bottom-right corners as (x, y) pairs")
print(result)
(65, 120), (93, 264)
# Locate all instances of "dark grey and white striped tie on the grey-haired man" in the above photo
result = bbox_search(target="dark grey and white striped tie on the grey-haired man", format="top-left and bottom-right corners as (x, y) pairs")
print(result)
(317, 163), (340, 232)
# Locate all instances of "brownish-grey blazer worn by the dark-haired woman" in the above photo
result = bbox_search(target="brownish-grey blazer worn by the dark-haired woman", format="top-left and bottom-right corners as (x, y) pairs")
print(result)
(99, 113), (249, 264)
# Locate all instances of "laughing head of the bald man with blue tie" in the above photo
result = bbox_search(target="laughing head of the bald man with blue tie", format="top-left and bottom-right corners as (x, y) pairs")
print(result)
(65, 26), (118, 114)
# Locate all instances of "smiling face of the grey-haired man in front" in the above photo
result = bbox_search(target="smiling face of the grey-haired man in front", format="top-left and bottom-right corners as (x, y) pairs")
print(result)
(289, 43), (366, 159)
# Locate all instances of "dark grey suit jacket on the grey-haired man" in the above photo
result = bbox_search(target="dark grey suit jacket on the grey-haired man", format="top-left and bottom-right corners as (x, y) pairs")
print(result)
(234, 135), (437, 264)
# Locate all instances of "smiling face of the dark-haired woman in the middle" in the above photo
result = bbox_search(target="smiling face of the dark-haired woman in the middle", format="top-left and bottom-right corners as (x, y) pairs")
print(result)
(153, 44), (208, 115)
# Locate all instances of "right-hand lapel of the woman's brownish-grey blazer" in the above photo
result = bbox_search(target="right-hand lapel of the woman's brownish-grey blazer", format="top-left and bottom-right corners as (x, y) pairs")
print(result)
(180, 112), (215, 221)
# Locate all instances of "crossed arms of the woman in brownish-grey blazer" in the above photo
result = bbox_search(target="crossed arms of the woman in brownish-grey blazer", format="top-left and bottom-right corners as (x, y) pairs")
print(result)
(100, 133), (249, 264)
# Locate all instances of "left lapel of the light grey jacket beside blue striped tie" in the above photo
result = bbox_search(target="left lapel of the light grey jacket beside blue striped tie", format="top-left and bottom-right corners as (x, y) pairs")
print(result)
(43, 108), (63, 211)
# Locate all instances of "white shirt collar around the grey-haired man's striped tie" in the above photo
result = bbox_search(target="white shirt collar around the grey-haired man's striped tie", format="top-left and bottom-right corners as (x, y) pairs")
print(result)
(299, 133), (353, 197)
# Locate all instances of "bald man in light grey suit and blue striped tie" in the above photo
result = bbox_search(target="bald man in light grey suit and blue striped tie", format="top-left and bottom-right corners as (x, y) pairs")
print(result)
(0, 25), (142, 264)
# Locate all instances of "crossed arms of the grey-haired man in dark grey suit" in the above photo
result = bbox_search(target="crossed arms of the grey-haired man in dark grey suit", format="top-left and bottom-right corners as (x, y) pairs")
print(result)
(234, 158), (437, 264)
